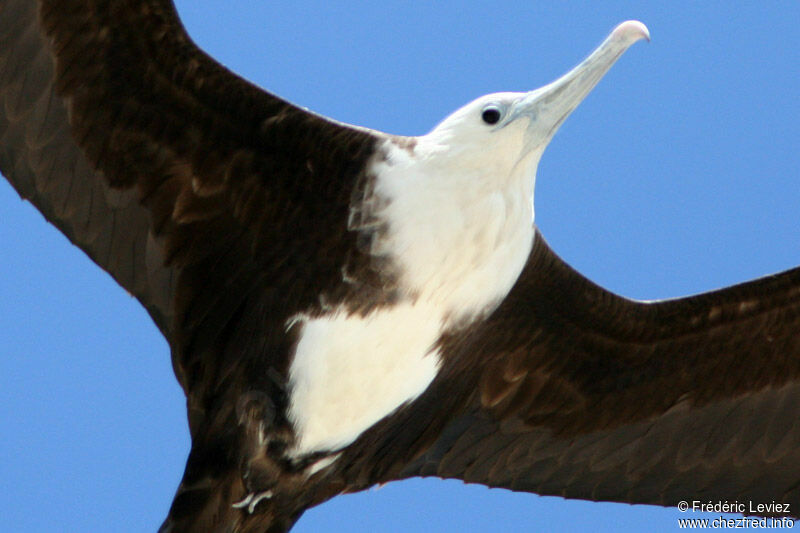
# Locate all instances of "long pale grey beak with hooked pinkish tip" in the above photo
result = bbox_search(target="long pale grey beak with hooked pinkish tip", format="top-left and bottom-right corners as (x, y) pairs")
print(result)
(510, 20), (650, 143)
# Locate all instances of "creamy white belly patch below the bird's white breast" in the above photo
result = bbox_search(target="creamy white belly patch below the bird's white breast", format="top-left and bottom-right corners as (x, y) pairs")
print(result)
(289, 303), (442, 455)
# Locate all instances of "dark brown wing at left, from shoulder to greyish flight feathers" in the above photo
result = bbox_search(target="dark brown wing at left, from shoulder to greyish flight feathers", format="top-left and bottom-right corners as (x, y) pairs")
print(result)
(0, 0), (376, 389)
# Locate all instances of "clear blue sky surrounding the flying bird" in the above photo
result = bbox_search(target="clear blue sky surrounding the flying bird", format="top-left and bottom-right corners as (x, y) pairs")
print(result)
(0, 0), (800, 532)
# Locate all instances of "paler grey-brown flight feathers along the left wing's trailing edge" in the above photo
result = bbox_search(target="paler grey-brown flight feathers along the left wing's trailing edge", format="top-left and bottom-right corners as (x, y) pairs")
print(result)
(0, 0), (174, 335)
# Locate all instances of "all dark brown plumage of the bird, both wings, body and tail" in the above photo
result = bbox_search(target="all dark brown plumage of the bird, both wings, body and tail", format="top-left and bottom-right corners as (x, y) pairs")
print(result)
(0, 0), (800, 531)
